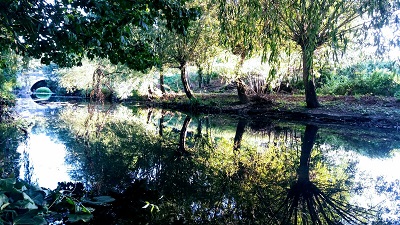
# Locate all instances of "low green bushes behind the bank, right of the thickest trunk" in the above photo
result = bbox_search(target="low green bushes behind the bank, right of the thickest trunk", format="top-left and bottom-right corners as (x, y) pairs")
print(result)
(319, 61), (400, 96)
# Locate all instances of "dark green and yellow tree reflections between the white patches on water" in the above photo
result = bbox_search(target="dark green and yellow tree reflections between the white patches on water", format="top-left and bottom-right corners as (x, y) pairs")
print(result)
(56, 106), (378, 224)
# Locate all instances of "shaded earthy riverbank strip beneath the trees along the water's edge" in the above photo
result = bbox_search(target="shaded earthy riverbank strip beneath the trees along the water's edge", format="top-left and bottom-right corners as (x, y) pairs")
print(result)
(139, 94), (400, 130)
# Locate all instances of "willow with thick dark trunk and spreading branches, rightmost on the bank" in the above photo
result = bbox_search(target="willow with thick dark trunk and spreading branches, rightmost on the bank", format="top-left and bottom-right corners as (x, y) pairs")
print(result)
(263, 0), (397, 108)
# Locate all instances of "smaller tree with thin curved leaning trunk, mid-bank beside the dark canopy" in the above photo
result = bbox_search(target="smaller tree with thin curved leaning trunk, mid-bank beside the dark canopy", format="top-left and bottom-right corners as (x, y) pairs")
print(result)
(154, 1), (217, 99)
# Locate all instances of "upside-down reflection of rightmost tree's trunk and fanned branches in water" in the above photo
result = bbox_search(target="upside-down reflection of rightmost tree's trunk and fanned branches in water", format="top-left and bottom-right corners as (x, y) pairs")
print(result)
(260, 125), (369, 225)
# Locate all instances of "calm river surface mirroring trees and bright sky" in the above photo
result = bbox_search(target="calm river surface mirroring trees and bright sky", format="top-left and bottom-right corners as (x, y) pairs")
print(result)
(10, 99), (400, 224)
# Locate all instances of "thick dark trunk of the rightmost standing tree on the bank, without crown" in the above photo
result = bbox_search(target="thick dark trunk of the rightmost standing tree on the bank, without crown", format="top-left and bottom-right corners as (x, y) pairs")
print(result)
(301, 46), (320, 108)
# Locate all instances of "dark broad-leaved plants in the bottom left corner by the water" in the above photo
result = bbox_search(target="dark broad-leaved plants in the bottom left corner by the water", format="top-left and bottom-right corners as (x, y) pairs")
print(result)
(0, 178), (114, 225)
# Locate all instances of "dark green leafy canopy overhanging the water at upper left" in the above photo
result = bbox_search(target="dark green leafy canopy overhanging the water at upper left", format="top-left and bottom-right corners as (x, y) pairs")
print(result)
(0, 0), (196, 70)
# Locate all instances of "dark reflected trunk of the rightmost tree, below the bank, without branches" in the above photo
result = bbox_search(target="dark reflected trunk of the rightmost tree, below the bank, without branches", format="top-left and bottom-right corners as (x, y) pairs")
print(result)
(297, 125), (318, 184)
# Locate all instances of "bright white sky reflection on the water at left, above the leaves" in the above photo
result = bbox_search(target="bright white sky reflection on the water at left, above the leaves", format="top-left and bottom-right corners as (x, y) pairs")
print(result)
(17, 134), (71, 189)
